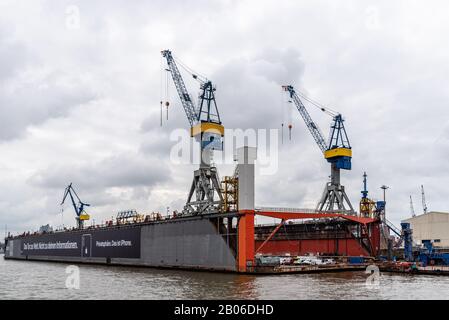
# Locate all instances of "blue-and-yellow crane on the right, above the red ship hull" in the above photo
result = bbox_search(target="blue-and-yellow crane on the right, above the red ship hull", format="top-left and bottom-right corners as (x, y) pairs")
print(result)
(282, 85), (356, 215)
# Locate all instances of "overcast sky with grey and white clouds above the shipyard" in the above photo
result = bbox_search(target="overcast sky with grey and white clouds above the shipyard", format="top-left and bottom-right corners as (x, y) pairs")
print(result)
(0, 0), (449, 232)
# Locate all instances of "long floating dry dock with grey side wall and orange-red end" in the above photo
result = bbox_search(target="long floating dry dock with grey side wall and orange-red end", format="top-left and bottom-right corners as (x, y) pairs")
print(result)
(5, 211), (379, 273)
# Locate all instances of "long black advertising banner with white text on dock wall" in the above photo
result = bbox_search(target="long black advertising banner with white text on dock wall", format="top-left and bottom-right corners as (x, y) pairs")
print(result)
(22, 228), (140, 259)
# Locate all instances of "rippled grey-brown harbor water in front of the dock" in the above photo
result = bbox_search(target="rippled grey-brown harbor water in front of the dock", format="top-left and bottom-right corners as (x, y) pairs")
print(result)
(0, 255), (449, 300)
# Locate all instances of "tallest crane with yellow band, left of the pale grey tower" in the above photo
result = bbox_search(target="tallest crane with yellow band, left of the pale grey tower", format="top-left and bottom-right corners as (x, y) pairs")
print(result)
(162, 50), (224, 215)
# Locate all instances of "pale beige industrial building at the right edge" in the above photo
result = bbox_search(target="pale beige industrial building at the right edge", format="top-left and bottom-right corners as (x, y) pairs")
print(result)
(403, 212), (449, 248)
